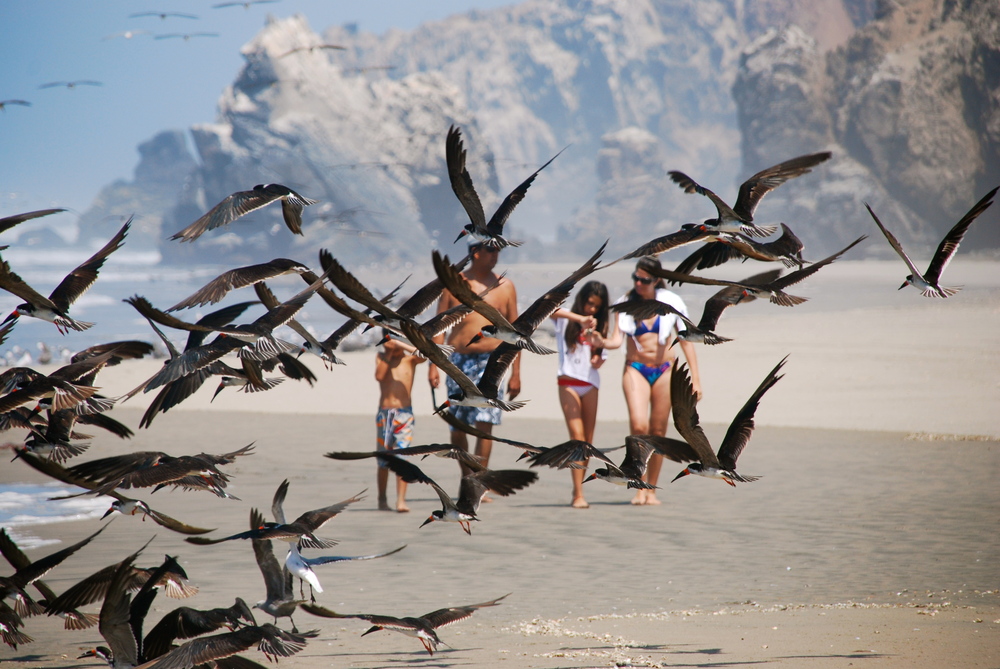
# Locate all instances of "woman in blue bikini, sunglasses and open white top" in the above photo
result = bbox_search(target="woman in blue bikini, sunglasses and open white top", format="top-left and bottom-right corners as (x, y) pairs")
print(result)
(595, 257), (701, 505)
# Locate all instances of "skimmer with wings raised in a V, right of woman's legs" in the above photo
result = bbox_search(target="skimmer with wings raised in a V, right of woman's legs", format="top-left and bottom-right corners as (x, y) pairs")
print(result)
(660, 356), (788, 487)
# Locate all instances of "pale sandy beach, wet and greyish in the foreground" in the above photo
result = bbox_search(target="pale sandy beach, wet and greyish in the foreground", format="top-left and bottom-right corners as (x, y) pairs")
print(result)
(0, 258), (1000, 669)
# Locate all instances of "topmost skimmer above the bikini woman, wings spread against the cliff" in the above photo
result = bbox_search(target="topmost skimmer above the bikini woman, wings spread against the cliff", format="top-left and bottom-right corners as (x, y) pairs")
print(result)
(669, 151), (831, 237)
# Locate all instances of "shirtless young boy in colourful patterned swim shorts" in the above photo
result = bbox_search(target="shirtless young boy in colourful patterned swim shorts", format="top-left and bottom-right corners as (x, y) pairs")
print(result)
(375, 332), (426, 513)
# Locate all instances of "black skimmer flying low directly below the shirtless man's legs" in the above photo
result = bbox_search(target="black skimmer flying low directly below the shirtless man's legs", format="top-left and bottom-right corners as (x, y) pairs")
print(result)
(366, 451), (538, 536)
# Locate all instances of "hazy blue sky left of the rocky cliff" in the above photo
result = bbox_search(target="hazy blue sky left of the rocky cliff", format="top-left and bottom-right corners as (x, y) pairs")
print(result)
(0, 0), (515, 224)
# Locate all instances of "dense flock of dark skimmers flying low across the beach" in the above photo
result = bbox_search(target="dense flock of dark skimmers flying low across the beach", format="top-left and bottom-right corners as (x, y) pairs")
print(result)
(0, 122), (997, 669)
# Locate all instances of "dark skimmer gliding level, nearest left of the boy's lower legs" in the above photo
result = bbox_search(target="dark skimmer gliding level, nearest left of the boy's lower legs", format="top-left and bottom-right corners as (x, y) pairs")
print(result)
(67, 444), (253, 499)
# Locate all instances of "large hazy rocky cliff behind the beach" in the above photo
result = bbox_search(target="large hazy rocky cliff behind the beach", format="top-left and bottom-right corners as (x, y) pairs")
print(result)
(82, 0), (1000, 264)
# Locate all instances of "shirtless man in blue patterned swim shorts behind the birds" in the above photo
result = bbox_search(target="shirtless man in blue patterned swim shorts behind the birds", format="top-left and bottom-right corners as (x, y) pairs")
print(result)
(427, 244), (521, 473)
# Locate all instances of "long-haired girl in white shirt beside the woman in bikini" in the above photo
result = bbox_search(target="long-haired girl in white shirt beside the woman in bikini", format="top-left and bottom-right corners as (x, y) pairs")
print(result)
(552, 281), (610, 509)
